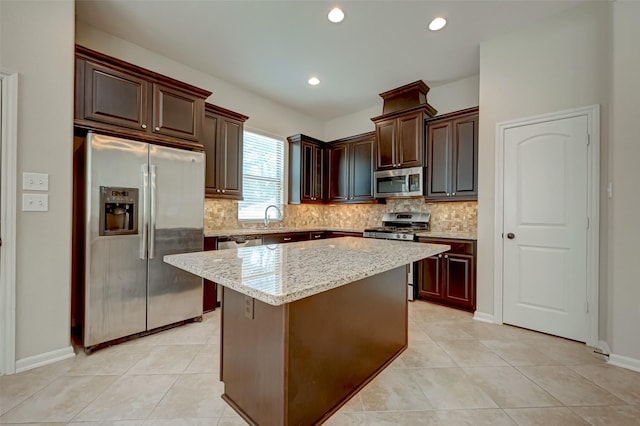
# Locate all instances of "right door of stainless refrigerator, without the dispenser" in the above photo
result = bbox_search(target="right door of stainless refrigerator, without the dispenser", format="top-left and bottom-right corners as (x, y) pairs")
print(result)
(147, 145), (204, 330)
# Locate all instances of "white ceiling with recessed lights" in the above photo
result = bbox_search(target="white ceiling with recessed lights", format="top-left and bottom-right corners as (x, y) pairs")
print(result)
(76, 0), (579, 121)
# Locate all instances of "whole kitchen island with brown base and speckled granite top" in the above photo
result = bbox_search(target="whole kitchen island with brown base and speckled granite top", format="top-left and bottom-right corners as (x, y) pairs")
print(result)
(164, 237), (449, 425)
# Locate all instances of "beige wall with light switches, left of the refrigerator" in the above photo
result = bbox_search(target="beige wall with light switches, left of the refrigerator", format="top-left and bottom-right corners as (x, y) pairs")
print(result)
(0, 0), (74, 364)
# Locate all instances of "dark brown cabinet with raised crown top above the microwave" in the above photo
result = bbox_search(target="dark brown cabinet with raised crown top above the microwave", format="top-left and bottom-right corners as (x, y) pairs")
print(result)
(371, 81), (436, 170)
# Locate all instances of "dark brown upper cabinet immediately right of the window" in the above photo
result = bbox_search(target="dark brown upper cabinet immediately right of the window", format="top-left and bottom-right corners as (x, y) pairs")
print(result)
(287, 134), (326, 204)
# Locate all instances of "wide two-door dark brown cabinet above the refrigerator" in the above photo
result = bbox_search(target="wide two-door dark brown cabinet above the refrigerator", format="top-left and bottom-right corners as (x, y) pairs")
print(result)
(74, 46), (211, 149)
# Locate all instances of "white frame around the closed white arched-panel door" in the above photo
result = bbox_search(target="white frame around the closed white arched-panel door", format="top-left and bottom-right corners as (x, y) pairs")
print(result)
(493, 105), (600, 347)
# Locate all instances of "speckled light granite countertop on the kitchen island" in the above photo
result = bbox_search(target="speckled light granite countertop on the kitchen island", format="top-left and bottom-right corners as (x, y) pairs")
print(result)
(164, 237), (450, 306)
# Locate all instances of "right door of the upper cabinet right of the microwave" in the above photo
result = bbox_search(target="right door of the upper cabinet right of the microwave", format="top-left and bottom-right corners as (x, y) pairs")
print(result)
(451, 114), (478, 198)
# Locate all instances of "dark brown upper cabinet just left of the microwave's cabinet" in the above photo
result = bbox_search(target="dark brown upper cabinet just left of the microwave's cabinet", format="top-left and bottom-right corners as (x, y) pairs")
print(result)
(327, 132), (376, 203)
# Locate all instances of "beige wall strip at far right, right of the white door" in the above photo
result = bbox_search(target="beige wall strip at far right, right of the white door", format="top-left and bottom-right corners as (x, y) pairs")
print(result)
(602, 2), (640, 364)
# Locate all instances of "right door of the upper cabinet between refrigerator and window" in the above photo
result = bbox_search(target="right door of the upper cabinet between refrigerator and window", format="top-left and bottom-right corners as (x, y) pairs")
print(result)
(216, 117), (243, 199)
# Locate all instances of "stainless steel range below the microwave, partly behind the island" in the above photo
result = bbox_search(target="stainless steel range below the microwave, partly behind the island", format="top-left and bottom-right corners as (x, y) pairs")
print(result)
(363, 212), (431, 300)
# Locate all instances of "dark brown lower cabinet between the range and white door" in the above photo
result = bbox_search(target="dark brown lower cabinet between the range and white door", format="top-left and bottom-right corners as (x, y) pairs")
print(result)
(418, 237), (476, 311)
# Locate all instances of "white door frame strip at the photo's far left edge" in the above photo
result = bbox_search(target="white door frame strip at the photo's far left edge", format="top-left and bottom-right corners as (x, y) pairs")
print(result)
(0, 72), (18, 375)
